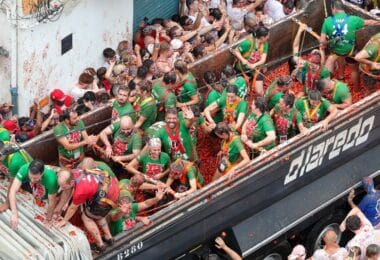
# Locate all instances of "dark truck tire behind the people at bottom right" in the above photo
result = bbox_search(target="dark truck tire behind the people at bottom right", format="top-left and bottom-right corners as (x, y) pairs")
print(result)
(305, 211), (346, 254)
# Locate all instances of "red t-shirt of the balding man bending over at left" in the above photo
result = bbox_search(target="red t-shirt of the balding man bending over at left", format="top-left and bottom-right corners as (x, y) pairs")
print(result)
(73, 174), (119, 205)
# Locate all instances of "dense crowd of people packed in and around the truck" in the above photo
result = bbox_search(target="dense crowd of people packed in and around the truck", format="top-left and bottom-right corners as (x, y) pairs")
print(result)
(0, 0), (380, 259)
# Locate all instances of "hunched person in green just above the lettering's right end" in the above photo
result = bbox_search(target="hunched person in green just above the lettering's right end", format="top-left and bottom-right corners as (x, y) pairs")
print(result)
(317, 78), (352, 109)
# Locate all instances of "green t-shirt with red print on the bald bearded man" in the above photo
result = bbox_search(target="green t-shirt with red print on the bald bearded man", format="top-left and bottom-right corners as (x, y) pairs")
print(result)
(110, 121), (142, 155)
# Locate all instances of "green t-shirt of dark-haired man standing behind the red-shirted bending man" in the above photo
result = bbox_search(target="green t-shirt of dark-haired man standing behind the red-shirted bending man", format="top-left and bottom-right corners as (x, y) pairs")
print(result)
(53, 120), (85, 159)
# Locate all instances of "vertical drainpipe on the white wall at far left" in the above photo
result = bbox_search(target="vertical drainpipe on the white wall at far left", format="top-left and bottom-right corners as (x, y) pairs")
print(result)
(10, 0), (19, 115)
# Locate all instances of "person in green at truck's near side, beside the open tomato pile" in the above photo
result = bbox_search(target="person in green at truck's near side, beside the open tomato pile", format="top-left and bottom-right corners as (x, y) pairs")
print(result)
(212, 122), (249, 181)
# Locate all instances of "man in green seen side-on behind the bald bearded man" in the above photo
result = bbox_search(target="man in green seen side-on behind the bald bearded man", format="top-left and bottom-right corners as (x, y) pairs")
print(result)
(135, 81), (157, 132)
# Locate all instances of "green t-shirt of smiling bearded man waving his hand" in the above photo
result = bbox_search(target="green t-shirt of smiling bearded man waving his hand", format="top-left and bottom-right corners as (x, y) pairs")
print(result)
(156, 112), (194, 160)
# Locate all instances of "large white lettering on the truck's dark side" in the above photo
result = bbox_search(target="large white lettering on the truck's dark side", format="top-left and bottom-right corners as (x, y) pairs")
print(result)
(284, 116), (375, 185)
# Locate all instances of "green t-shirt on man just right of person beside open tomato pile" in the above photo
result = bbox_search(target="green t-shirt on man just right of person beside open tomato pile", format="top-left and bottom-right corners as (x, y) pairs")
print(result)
(248, 113), (276, 150)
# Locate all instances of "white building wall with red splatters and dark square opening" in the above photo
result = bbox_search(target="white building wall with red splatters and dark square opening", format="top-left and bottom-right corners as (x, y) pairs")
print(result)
(0, 0), (133, 115)
